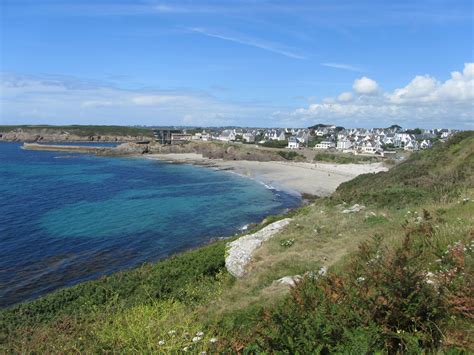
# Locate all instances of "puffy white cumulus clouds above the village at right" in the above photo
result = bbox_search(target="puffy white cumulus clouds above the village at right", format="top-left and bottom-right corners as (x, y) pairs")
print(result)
(274, 63), (474, 129)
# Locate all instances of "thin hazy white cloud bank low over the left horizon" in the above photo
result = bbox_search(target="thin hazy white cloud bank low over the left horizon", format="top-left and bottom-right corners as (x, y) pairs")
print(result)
(0, 75), (271, 126)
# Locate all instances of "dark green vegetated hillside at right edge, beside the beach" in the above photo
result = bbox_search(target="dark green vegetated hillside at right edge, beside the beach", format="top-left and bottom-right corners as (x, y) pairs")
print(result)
(333, 131), (474, 208)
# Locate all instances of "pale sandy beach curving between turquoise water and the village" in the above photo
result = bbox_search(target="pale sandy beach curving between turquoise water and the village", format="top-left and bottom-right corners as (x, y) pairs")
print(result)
(147, 153), (388, 196)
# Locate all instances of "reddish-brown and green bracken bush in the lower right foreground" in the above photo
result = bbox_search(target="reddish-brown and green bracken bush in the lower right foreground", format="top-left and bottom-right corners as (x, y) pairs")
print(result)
(249, 211), (473, 354)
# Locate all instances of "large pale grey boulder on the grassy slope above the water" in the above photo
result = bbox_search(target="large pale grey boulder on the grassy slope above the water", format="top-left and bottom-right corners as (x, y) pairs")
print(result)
(225, 218), (291, 278)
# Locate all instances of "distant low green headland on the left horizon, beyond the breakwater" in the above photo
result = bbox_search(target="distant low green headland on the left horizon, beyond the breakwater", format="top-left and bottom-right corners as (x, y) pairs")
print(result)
(0, 125), (153, 137)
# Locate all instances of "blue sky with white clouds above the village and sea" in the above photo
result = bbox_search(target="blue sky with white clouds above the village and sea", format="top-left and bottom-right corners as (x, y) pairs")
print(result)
(0, 0), (474, 129)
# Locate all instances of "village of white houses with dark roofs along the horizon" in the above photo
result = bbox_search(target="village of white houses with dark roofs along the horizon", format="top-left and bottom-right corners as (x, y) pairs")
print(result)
(154, 124), (457, 156)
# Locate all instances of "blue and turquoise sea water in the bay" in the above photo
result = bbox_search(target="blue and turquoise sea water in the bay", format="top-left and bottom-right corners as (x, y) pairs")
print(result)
(0, 142), (301, 308)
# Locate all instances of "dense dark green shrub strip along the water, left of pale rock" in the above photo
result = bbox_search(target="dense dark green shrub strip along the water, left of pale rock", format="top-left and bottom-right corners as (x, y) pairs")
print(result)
(0, 241), (225, 341)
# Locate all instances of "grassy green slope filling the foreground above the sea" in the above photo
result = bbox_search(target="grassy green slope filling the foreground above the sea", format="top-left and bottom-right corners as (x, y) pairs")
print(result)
(0, 132), (474, 353)
